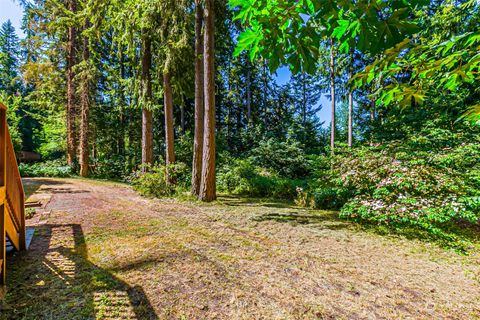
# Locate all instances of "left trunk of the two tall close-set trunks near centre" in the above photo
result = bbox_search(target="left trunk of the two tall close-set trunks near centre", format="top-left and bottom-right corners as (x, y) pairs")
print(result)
(192, 0), (205, 196)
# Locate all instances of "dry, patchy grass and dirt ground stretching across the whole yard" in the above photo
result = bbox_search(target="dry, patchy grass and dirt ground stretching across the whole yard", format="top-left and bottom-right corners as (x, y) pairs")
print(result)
(0, 179), (480, 320)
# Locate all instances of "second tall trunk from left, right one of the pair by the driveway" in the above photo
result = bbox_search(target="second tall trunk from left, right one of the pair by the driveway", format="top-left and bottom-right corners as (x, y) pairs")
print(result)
(80, 22), (90, 177)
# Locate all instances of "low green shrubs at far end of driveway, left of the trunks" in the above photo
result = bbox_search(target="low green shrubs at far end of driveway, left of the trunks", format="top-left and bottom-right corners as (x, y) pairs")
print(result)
(18, 160), (73, 178)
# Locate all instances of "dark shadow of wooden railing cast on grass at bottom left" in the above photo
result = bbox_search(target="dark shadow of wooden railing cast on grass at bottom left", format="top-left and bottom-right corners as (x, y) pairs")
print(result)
(0, 224), (158, 319)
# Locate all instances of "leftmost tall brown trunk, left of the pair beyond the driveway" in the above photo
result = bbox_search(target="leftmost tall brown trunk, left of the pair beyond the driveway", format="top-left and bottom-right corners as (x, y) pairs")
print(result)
(67, 0), (77, 166)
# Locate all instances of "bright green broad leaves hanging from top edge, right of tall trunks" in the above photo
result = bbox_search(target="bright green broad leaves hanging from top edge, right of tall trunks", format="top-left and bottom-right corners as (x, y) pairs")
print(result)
(229, 0), (427, 74)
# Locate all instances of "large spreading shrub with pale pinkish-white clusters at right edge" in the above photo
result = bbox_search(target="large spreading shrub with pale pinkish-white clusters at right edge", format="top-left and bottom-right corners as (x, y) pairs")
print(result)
(297, 127), (480, 247)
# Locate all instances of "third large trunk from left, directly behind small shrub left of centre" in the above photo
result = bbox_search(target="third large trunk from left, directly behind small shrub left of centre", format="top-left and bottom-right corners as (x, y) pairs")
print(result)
(142, 31), (153, 169)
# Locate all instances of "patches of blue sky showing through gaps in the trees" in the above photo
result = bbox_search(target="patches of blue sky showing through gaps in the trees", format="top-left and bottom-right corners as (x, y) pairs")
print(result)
(0, 0), (331, 127)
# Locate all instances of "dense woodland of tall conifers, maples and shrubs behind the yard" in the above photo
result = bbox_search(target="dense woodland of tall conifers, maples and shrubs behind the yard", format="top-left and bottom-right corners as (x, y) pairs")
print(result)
(0, 0), (480, 246)
